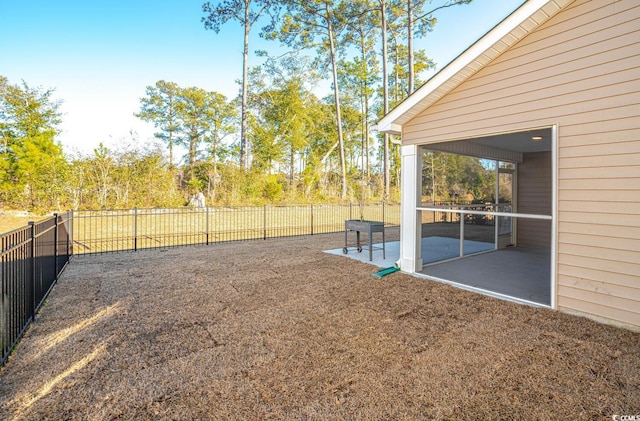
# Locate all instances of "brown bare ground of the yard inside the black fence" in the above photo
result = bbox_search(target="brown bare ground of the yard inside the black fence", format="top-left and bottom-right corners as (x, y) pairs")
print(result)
(0, 234), (640, 420)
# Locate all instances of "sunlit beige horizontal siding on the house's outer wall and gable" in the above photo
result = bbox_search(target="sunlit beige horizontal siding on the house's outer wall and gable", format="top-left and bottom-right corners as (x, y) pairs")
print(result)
(402, 0), (640, 328)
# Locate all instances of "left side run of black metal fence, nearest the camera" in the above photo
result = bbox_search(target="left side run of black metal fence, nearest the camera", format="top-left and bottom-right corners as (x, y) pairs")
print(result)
(0, 211), (73, 363)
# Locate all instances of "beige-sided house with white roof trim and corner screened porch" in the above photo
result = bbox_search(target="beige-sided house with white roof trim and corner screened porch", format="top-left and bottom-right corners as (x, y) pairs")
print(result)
(378, 0), (640, 330)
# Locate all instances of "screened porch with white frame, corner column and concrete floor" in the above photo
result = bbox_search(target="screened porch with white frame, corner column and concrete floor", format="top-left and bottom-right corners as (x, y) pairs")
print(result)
(400, 127), (554, 306)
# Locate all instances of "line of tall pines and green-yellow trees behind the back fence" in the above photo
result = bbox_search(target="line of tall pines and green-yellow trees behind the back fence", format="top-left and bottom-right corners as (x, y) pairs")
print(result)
(0, 0), (504, 213)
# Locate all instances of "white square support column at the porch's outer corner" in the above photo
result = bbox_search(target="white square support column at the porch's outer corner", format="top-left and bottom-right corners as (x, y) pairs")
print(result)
(400, 145), (422, 273)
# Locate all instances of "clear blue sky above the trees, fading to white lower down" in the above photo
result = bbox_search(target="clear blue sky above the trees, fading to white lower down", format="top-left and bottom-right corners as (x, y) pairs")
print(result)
(0, 0), (524, 153)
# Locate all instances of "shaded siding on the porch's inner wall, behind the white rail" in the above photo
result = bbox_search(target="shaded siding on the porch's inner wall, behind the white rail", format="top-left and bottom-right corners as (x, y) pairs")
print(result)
(517, 152), (551, 247)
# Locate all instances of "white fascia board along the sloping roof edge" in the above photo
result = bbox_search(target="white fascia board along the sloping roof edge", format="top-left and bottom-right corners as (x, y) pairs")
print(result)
(378, 0), (572, 134)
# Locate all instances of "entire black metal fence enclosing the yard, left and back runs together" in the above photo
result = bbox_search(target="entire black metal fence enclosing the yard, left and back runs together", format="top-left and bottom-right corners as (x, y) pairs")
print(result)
(0, 202), (400, 364)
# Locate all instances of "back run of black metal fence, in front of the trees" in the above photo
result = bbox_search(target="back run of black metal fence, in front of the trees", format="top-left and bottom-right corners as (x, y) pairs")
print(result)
(73, 202), (400, 254)
